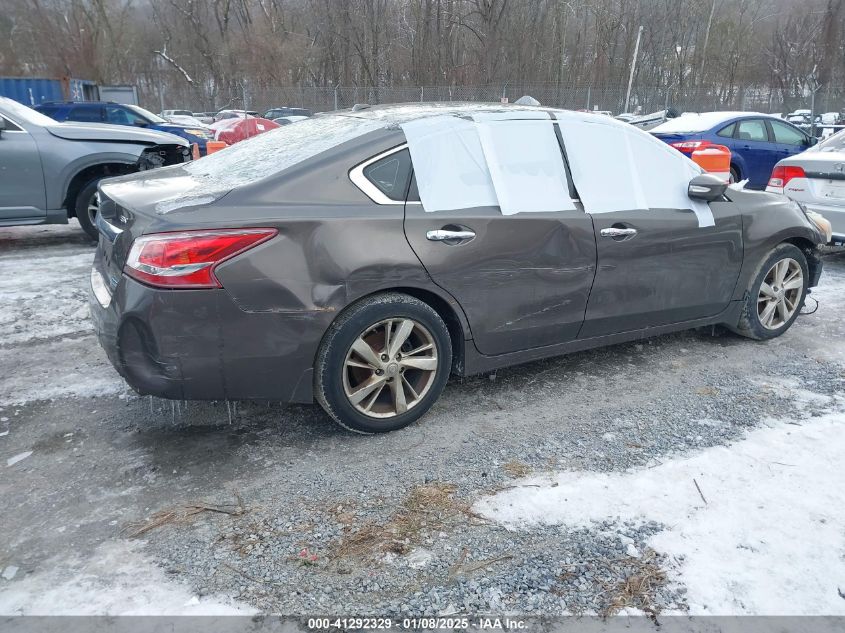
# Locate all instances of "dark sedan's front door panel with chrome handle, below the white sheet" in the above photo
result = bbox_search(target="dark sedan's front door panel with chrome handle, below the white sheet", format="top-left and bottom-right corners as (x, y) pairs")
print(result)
(579, 202), (742, 338)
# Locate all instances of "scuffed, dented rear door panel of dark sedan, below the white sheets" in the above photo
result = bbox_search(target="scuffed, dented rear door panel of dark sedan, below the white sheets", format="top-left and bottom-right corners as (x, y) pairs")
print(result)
(405, 185), (596, 355)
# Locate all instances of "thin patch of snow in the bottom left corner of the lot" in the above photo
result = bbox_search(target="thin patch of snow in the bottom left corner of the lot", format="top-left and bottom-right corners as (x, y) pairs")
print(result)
(0, 541), (255, 616)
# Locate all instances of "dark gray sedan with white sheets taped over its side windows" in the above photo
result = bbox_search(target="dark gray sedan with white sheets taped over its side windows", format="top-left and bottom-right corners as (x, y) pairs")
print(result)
(91, 104), (826, 433)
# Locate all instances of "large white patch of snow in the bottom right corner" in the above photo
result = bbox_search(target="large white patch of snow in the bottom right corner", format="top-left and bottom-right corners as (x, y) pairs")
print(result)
(475, 404), (845, 615)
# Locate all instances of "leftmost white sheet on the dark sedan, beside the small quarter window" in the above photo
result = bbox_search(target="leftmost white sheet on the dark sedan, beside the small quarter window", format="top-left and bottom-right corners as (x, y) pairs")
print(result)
(401, 116), (499, 211)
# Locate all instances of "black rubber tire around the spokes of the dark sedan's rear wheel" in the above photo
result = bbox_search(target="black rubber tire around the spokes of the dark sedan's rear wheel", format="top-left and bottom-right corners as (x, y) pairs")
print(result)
(314, 292), (452, 433)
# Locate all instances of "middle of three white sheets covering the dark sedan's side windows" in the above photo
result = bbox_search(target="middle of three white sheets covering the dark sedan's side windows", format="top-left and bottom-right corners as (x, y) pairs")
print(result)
(473, 118), (575, 215)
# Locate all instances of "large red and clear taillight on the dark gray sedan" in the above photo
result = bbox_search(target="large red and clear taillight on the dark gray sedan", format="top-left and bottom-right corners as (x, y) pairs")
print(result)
(124, 229), (278, 288)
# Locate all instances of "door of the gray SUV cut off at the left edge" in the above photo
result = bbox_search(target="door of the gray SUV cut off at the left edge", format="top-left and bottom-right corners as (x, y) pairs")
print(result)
(0, 120), (46, 221)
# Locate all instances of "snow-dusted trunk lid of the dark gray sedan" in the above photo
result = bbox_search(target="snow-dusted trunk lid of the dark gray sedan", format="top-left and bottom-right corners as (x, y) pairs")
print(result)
(100, 165), (229, 216)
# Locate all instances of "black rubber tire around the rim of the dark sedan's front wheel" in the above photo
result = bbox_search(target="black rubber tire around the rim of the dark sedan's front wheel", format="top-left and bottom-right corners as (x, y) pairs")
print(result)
(731, 244), (810, 341)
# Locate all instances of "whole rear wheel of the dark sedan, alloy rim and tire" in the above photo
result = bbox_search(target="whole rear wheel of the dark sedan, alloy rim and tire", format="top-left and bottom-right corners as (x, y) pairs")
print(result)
(315, 294), (452, 433)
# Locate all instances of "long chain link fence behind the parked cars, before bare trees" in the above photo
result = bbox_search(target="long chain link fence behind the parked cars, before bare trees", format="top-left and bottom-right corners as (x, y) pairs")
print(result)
(138, 77), (845, 114)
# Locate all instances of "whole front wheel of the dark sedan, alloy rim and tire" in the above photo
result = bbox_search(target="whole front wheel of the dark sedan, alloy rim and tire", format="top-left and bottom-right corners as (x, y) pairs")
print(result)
(732, 244), (809, 340)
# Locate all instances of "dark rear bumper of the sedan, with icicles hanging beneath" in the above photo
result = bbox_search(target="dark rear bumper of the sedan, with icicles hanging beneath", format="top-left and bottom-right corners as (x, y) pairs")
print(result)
(89, 262), (327, 403)
